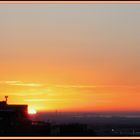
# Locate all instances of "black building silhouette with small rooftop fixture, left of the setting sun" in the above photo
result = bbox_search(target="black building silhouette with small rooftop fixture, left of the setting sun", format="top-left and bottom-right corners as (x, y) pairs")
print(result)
(0, 96), (50, 136)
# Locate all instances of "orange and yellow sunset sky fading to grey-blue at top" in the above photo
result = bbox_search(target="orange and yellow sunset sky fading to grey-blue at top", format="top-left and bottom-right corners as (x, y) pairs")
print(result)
(0, 4), (140, 111)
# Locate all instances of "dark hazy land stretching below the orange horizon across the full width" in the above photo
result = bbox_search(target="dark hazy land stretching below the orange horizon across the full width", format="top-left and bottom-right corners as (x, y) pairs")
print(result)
(0, 112), (140, 137)
